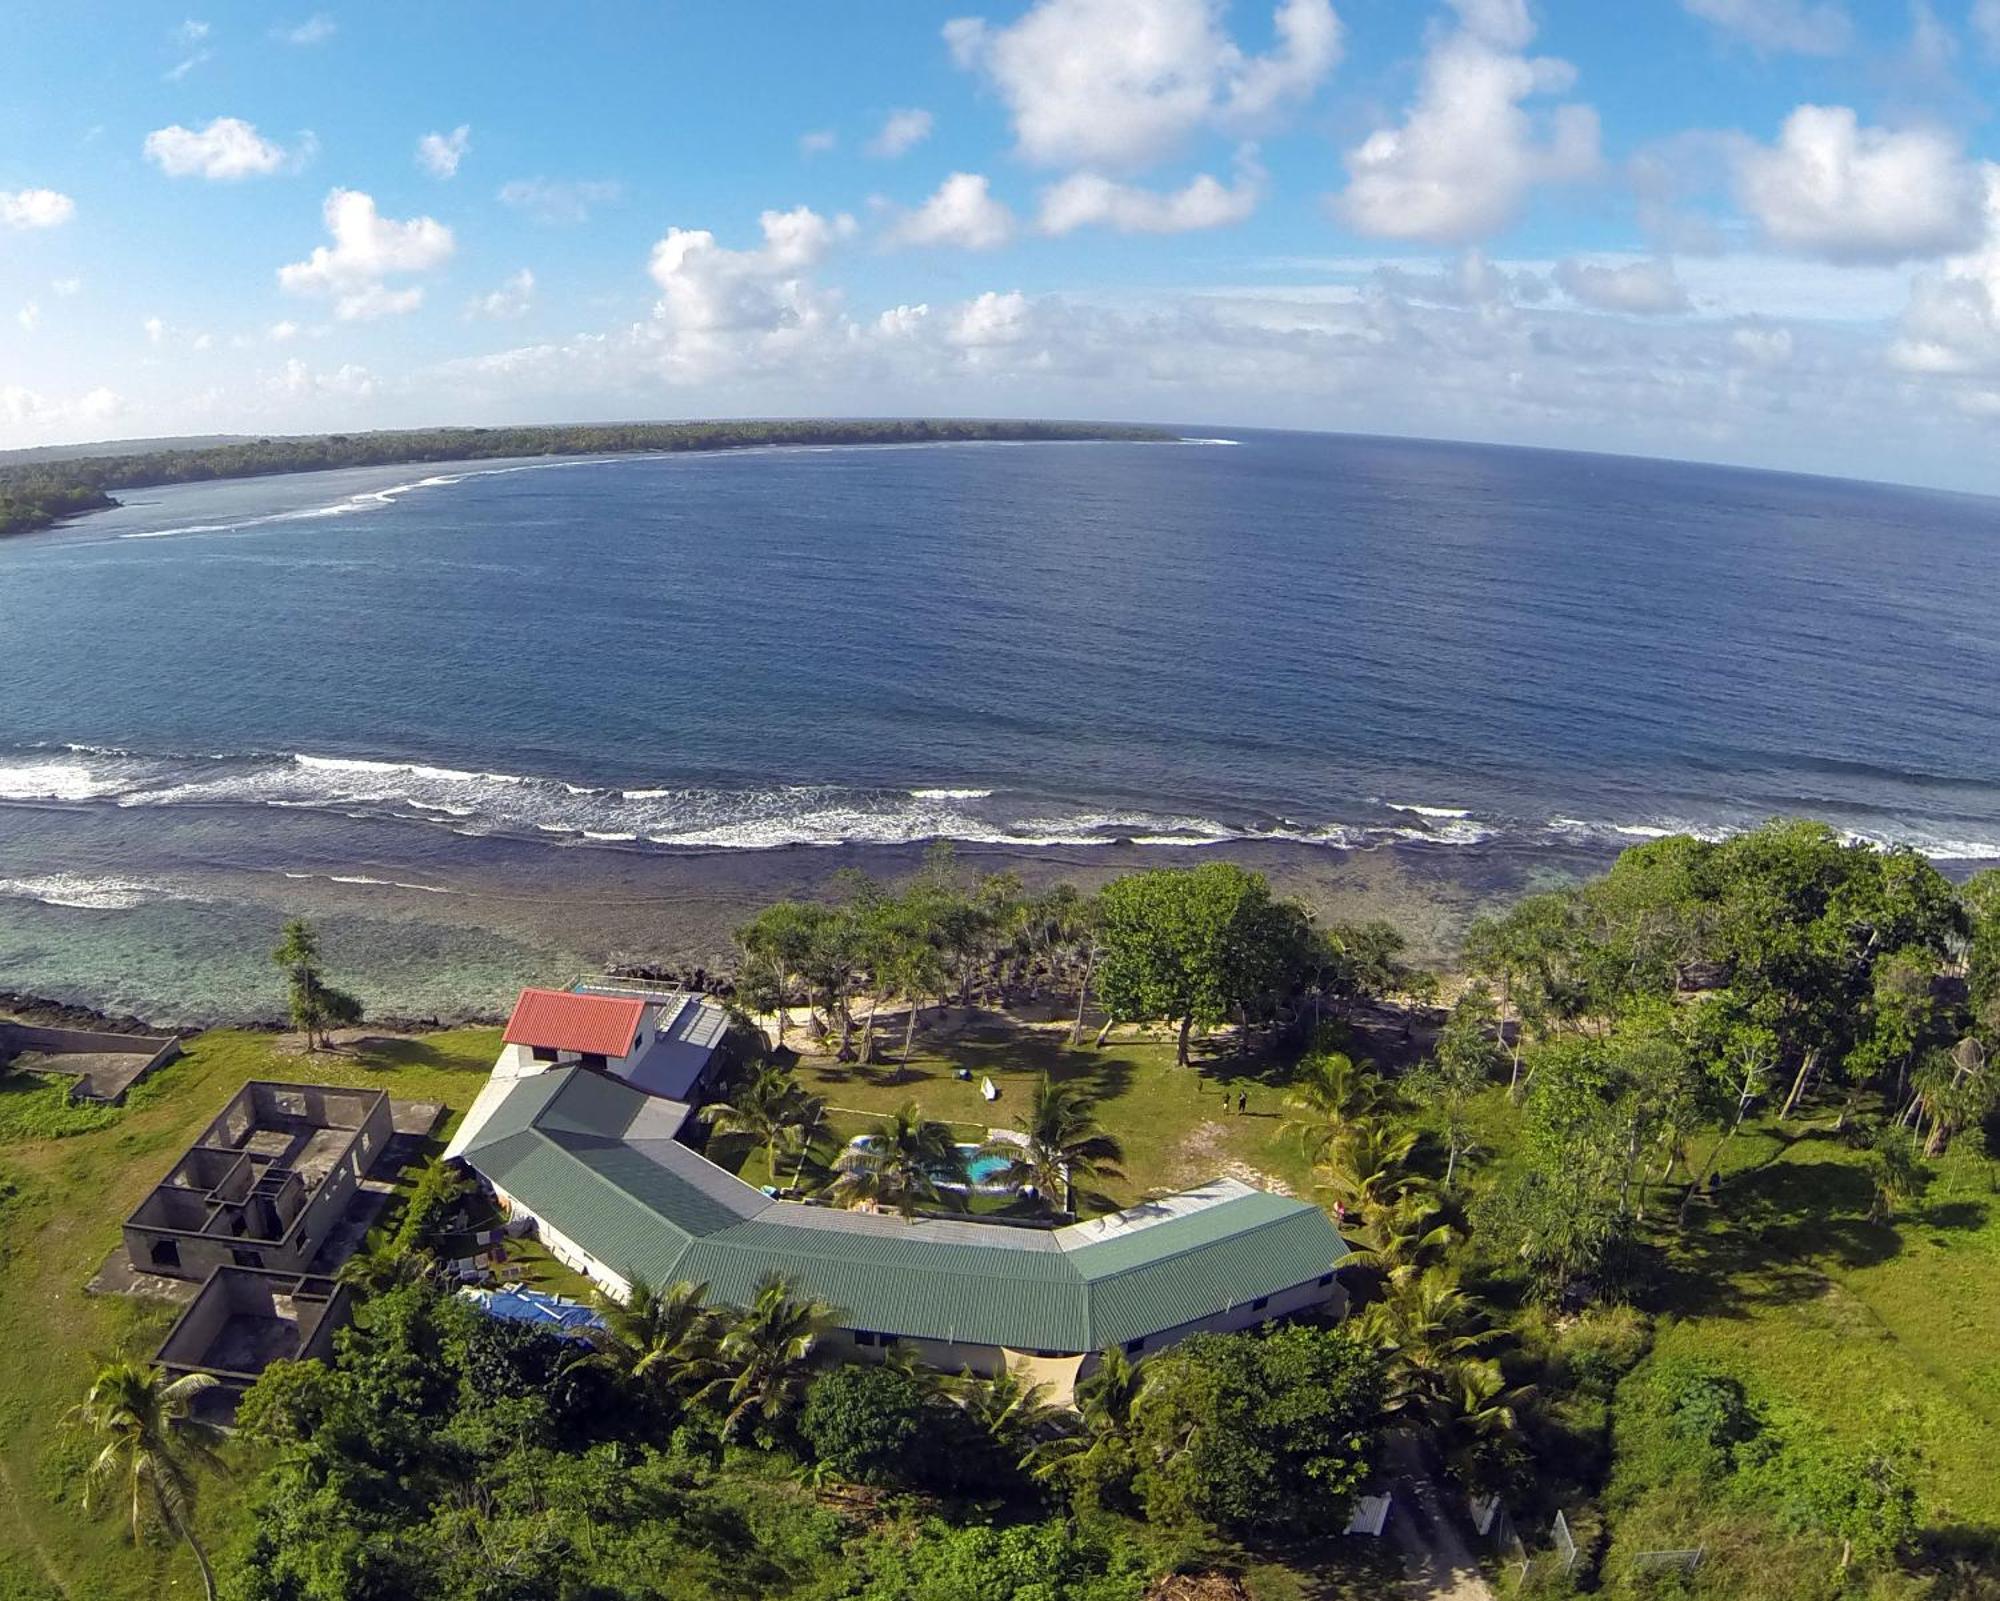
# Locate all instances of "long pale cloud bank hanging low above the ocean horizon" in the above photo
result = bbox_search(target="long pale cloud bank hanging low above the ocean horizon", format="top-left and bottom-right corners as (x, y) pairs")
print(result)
(410, 212), (2000, 488)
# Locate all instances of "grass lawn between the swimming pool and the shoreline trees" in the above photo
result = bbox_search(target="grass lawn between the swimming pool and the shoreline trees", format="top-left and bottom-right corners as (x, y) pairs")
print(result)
(780, 1023), (1312, 1205)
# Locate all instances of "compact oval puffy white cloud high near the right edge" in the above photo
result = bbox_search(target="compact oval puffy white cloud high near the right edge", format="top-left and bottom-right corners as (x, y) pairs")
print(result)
(1736, 106), (1980, 262)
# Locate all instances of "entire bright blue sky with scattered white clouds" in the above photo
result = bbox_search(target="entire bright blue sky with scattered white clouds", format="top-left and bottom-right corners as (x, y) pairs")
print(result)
(0, 0), (2000, 490)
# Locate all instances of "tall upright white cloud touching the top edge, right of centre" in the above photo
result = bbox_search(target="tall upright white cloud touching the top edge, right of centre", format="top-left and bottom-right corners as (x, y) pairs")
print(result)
(1338, 0), (1598, 244)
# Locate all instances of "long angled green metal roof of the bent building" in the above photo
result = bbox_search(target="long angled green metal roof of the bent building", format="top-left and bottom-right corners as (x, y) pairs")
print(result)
(466, 1067), (1348, 1353)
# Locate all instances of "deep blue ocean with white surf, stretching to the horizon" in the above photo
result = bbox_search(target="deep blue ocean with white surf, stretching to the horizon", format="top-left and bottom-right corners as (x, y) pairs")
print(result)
(0, 426), (2000, 1020)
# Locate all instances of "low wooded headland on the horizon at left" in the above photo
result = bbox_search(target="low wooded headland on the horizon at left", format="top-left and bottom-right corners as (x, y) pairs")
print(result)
(0, 418), (1176, 534)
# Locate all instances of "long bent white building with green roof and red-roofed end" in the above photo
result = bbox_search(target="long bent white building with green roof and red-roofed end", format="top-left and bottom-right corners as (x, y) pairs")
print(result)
(446, 991), (1348, 1397)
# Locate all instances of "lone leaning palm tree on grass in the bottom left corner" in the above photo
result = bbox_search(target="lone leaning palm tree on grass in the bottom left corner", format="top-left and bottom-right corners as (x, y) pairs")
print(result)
(70, 1361), (222, 1601)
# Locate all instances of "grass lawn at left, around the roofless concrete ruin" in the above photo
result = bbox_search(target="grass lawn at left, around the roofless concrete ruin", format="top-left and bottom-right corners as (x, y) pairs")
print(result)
(0, 1029), (500, 1601)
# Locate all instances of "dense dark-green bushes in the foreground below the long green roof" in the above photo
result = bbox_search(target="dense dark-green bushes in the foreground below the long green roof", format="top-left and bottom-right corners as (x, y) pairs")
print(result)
(224, 1279), (1382, 1601)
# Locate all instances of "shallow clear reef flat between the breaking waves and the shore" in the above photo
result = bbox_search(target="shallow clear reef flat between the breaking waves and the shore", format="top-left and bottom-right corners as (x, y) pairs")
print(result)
(0, 788), (1614, 1029)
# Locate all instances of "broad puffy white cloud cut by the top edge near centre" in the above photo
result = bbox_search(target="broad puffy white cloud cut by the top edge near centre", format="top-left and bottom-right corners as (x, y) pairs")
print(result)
(944, 0), (1340, 172)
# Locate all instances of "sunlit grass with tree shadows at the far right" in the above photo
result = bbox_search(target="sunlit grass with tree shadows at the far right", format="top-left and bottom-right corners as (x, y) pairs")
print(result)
(1624, 1117), (2000, 1527)
